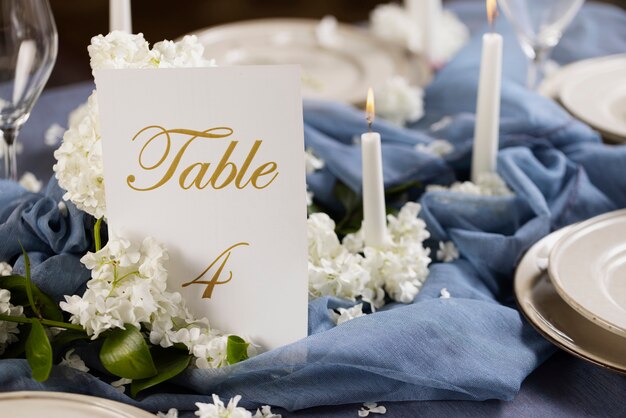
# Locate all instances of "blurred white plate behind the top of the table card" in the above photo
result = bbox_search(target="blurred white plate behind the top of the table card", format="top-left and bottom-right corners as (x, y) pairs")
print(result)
(183, 19), (422, 104)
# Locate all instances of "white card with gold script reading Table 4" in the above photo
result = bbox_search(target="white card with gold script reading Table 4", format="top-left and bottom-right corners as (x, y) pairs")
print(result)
(95, 66), (308, 349)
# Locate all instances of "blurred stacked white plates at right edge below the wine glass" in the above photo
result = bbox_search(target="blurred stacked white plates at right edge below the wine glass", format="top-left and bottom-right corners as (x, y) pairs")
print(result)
(539, 54), (626, 143)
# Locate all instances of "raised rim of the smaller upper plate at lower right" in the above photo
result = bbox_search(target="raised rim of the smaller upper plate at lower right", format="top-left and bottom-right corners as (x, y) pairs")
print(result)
(547, 209), (626, 337)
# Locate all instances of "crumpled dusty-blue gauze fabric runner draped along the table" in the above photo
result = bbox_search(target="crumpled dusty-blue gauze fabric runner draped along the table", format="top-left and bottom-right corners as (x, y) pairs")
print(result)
(0, 2), (626, 411)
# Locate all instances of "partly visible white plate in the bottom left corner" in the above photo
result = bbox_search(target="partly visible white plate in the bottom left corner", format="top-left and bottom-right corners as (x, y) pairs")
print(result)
(0, 392), (154, 418)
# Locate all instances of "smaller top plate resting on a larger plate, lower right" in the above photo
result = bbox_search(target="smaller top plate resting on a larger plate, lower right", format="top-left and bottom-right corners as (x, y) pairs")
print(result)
(548, 209), (626, 337)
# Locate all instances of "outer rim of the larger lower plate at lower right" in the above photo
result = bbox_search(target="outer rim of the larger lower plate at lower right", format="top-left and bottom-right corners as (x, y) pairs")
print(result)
(513, 224), (626, 375)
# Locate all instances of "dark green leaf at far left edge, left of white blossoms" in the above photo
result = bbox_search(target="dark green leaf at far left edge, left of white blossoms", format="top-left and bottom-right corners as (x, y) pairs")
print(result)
(0, 275), (63, 321)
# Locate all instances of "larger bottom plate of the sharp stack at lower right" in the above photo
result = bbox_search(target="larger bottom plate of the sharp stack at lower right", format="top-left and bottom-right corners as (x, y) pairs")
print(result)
(515, 227), (626, 373)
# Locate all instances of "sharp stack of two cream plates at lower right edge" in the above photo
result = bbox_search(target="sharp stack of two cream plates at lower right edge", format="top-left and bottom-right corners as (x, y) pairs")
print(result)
(515, 210), (626, 373)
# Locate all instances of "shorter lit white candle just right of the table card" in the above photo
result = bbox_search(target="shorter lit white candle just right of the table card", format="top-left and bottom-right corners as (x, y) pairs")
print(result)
(361, 88), (387, 248)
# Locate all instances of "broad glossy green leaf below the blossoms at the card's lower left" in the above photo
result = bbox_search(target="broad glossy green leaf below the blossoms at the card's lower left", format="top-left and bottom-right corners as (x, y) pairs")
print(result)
(100, 325), (157, 380)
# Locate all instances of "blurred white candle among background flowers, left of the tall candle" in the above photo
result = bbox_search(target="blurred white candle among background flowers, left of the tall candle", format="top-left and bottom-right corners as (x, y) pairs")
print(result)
(404, 0), (442, 63)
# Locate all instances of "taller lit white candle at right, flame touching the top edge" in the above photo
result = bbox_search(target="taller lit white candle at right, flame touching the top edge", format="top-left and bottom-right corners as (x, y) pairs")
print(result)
(472, 0), (502, 182)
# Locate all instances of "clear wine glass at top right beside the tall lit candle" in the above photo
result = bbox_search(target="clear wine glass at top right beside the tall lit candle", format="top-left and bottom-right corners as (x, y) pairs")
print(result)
(500, 0), (584, 90)
